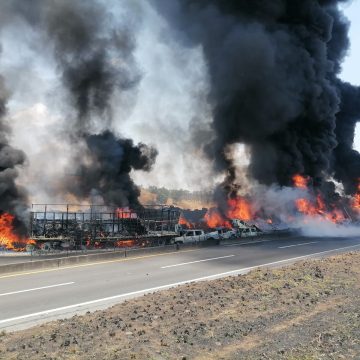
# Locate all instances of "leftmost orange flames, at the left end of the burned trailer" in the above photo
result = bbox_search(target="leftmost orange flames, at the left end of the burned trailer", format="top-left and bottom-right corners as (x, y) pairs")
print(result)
(0, 213), (33, 251)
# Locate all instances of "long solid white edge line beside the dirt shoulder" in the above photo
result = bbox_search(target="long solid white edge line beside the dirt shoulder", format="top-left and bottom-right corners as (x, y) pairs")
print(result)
(0, 244), (360, 325)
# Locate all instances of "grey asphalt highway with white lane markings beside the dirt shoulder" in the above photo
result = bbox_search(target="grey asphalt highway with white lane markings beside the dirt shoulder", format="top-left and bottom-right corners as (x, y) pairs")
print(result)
(0, 237), (360, 331)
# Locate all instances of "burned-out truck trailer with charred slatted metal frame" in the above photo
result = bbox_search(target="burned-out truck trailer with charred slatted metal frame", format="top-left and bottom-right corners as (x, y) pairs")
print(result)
(30, 204), (180, 248)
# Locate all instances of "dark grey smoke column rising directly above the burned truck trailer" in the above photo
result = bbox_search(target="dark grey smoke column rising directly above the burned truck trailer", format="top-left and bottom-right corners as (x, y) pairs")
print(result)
(10, 0), (157, 206)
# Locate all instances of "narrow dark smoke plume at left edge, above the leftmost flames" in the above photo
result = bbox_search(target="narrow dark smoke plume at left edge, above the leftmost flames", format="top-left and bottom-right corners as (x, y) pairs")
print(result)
(0, 72), (27, 235)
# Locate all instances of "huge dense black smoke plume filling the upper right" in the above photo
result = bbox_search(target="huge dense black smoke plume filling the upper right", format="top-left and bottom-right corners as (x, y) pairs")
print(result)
(154, 0), (360, 200)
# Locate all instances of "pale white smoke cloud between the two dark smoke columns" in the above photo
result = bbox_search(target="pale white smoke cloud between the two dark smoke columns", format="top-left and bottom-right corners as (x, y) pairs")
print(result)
(115, 2), (218, 190)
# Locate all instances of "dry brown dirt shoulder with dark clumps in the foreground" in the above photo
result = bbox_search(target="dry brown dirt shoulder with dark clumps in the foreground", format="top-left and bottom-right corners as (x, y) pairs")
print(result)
(0, 252), (360, 360)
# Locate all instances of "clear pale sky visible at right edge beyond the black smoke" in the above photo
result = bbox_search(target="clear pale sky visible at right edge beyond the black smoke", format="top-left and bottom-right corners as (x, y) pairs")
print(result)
(341, 0), (360, 151)
